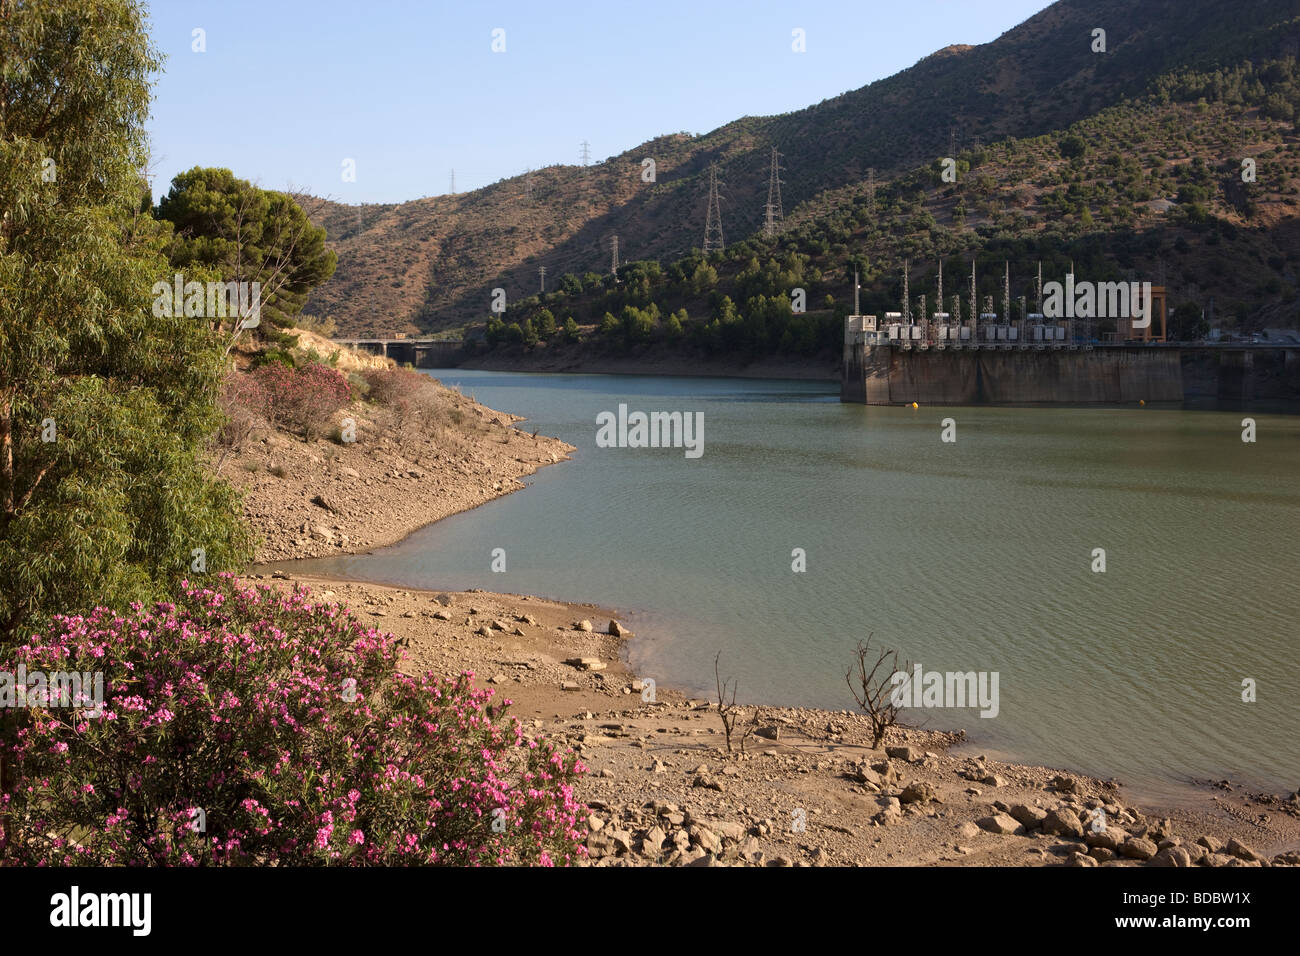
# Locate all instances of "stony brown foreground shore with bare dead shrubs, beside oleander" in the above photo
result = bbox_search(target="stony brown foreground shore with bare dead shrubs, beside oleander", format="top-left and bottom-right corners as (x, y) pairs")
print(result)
(253, 567), (1300, 866)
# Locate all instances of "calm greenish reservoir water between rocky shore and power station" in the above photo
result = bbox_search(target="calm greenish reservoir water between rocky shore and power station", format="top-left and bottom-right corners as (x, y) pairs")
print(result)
(287, 369), (1300, 792)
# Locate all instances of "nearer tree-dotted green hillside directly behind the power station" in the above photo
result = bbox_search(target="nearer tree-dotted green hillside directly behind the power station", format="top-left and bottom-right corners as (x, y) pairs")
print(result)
(462, 59), (1300, 362)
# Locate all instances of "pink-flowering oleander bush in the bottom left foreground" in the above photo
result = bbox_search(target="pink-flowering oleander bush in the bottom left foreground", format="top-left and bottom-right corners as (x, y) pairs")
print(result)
(0, 575), (585, 865)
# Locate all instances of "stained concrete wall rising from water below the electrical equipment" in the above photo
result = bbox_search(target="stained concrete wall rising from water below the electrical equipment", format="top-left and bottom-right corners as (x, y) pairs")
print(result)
(840, 343), (1183, 405)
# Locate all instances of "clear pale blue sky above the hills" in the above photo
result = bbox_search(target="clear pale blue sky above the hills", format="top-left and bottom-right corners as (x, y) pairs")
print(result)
(146, 0), (1048, 203)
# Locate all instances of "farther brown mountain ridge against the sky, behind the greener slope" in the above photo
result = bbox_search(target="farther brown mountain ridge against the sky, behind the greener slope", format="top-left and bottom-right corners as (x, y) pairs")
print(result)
(302, 0), (1300, 334)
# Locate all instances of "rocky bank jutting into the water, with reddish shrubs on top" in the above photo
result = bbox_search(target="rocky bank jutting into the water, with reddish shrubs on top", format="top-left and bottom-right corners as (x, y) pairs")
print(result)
(211, 335), (572, 561)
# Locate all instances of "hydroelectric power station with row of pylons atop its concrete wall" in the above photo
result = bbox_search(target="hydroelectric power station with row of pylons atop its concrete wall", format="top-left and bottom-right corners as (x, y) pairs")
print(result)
(840, 263), (1296, 405)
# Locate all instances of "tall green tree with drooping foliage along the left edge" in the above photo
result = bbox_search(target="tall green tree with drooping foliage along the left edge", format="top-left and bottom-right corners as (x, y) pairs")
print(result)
(0, 0), (251, 646)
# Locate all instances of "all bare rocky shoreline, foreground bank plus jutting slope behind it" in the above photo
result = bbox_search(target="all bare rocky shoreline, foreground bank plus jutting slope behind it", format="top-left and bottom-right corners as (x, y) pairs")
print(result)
(233, 366), (1300, 866)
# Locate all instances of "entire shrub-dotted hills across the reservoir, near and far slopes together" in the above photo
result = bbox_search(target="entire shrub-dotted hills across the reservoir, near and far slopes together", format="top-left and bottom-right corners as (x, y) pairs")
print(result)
(299, 0), (1300, 343)
